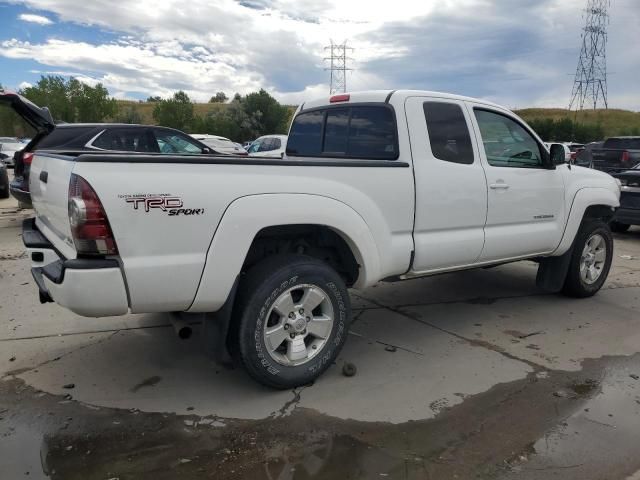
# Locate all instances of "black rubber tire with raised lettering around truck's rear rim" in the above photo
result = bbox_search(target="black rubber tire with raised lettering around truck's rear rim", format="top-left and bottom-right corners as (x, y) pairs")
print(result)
(230, 255), (351, 389)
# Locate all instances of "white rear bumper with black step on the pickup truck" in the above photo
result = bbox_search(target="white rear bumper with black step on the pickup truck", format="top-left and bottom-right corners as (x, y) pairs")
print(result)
(22, 219), (129, 317)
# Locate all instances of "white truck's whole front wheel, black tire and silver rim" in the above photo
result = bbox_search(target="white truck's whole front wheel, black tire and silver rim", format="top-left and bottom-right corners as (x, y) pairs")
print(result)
(562, 220), (613, 298)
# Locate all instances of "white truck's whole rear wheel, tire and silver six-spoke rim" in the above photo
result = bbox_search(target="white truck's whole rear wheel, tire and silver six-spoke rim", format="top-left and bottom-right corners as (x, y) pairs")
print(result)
(233, 255), (351, 389)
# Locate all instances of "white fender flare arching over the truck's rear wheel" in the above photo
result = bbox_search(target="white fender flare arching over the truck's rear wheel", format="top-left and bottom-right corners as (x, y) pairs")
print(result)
(187, 193), (381, 312)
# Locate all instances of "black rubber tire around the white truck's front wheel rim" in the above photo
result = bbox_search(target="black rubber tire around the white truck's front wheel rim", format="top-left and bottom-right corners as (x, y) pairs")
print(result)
(562, 220), (613, 298)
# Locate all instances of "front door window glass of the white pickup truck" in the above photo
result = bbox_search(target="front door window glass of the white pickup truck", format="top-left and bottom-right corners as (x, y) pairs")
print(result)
(474, 108), (543, 168)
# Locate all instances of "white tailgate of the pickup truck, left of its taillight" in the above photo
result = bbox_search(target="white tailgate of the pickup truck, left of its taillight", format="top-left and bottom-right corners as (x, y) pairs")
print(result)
(29, 153), (76, 259)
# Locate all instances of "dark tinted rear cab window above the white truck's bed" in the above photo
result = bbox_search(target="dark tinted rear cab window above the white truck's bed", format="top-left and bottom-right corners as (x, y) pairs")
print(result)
(287, 104), (398, 160)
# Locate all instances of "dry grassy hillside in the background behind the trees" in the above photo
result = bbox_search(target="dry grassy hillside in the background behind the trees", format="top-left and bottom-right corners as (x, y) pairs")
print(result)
(118, 100), (640, 137)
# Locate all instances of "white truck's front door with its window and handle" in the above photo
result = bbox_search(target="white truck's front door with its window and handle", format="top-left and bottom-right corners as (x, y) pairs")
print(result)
(468, 104), (565, 262)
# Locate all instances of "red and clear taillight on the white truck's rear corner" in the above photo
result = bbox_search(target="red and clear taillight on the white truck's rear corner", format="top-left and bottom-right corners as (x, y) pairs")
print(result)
(69, 174), (118, 255)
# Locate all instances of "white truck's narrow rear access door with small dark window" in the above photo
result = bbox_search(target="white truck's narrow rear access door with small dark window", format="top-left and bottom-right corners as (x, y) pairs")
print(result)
(405, 97), (487, 273)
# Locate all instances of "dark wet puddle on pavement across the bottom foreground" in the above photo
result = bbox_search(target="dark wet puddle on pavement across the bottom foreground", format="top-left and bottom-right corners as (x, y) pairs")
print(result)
(0, 355), (640, 480)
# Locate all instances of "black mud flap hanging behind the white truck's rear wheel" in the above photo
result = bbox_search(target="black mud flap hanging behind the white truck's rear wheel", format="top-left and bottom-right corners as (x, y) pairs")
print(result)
(202, 278), (238, 367)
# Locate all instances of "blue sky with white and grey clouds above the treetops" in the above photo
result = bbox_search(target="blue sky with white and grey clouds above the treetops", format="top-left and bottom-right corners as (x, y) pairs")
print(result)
(0, 0), (640, 110)
